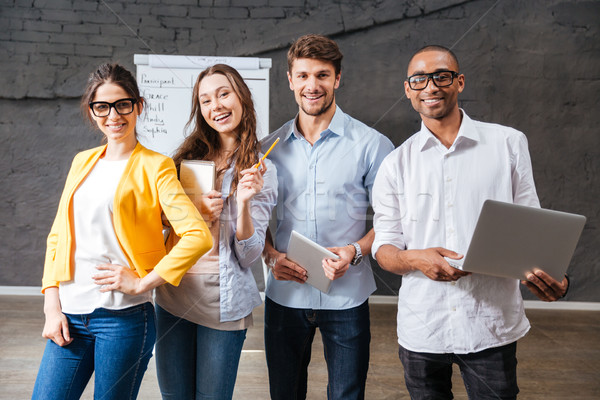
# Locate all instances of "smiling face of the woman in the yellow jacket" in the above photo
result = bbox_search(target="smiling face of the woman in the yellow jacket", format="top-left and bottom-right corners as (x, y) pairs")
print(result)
(89, 82), (142, 143)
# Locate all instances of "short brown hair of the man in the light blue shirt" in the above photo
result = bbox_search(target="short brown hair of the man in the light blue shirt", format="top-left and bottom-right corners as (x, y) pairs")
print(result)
(287, 34), (344, 75)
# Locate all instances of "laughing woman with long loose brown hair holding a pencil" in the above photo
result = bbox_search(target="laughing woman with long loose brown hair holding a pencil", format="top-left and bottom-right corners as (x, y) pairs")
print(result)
(156, 64), (277, 399)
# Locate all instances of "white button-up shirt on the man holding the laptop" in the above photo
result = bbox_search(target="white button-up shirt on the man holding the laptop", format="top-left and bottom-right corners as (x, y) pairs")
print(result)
(373, 110), (539, 354)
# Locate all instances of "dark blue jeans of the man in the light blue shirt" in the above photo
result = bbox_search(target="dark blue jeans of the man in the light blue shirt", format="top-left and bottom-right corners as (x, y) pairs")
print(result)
(265, 297), (371, 400)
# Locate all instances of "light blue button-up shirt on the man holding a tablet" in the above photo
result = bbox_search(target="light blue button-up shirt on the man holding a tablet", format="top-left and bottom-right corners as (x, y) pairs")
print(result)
(261, 107), (394, 310)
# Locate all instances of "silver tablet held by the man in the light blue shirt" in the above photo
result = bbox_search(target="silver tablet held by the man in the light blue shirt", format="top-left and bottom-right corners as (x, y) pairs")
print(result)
(286, 231), (340, 293)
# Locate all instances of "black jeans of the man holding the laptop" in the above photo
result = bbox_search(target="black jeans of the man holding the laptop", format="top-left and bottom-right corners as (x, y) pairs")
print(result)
(398, 342), (519, 400)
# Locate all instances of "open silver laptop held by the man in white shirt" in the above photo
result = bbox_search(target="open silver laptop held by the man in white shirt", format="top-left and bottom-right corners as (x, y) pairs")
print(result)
(446, 200), (586, 282)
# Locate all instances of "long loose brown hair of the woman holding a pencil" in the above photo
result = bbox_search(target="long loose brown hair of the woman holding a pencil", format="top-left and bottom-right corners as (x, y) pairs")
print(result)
(173, 64), (260, 194)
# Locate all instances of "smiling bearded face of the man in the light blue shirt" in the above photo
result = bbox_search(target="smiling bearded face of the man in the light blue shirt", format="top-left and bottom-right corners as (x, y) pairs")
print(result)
(288, 58), (341, 117)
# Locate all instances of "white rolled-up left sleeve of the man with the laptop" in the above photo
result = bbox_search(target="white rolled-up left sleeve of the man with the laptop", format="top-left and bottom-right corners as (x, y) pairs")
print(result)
(371, 152), (406, 258)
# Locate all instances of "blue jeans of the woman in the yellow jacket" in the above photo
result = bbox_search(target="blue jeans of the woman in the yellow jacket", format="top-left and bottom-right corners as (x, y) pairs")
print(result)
(32, 303), (156, 400)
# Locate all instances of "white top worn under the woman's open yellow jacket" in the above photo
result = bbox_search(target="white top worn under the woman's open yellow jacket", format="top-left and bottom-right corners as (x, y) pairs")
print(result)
(58, 158), (152, 314)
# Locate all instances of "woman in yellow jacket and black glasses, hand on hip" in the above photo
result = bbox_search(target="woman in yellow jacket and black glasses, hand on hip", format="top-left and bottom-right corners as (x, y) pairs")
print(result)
(33, 64), (212, 399)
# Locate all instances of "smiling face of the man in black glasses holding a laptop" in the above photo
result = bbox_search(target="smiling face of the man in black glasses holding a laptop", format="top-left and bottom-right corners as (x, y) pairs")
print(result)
(404, 50), (465, 120)
